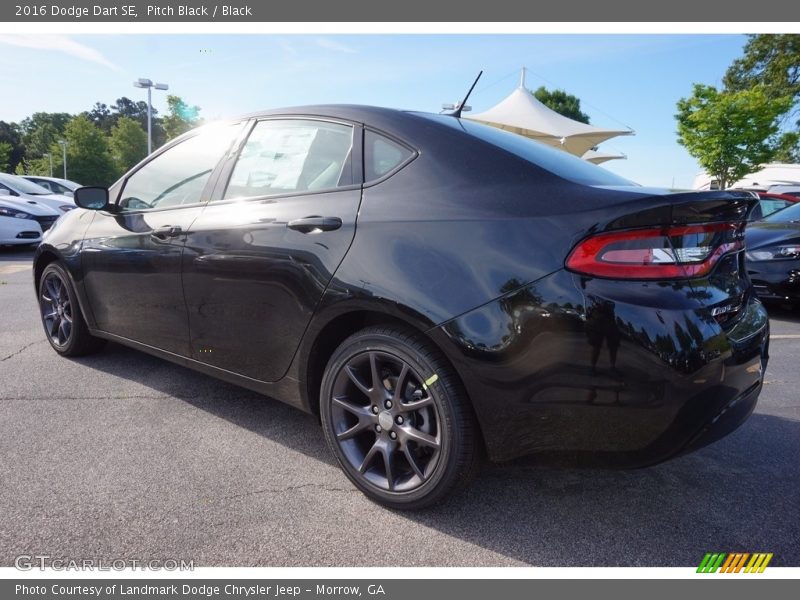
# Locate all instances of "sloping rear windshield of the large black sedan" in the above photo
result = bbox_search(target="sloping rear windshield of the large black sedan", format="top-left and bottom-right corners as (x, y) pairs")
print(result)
(418, 113), (637, 186)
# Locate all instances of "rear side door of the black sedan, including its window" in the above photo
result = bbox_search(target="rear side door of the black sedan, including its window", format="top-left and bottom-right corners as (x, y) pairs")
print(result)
(183, 117), (362, 381)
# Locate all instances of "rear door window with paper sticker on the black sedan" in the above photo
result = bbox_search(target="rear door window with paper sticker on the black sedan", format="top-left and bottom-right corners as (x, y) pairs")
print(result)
(224, 119), (353, 198)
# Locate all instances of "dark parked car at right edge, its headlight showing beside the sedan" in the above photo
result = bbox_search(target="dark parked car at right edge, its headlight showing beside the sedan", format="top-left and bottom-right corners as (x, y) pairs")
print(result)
(746, 204), (800, 304)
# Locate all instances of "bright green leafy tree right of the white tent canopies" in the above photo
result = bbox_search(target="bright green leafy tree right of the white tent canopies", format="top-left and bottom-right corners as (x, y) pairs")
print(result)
(675, 84), (791, 189)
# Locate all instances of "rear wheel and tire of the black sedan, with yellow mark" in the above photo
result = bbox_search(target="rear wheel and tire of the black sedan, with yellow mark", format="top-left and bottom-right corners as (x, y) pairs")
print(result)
(320, 326), (480, 510)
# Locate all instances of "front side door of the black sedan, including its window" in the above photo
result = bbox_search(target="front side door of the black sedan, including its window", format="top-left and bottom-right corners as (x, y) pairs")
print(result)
(81, 123), (243, 356)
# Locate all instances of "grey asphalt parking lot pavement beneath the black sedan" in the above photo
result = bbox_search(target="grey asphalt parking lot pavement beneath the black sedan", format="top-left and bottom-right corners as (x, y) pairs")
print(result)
(0, 249), (800, 566)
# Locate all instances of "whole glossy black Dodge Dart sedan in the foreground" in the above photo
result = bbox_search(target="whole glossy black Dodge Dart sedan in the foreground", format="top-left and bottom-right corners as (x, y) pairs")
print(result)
(34, 106), (768, 508)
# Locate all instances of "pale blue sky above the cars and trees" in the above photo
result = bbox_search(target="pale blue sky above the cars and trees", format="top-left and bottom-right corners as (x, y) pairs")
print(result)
(0, 34), (746, 188)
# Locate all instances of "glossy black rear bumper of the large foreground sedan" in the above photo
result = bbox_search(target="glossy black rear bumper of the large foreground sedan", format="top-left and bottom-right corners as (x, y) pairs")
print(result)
(429, 271), (769, 466)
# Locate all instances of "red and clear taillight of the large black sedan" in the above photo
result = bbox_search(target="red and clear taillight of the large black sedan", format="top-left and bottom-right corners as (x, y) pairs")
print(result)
(566, 223), (744, 279)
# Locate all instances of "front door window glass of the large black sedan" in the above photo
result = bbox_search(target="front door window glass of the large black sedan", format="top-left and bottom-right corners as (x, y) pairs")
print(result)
(119, 123), (241, 210)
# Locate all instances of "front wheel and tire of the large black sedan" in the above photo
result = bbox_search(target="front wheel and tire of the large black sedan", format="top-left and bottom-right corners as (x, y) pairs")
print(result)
(37, 262), (105, 356)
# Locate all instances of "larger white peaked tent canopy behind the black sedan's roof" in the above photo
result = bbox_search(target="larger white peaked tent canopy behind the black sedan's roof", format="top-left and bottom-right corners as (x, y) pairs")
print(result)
(465, 69), (633, 156)
